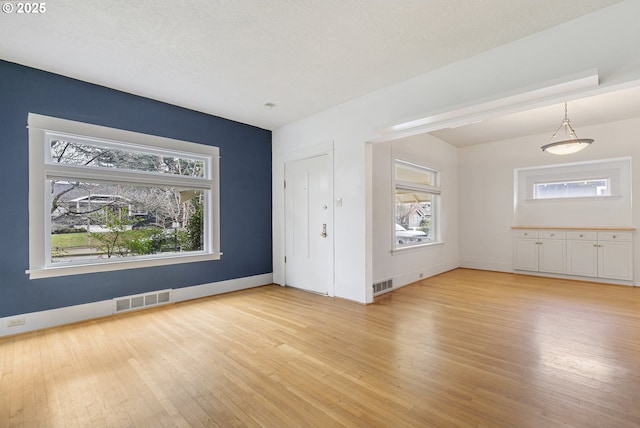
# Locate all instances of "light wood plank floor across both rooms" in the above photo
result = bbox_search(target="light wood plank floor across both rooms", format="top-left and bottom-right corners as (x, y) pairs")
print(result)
(0, 269), (640, 428)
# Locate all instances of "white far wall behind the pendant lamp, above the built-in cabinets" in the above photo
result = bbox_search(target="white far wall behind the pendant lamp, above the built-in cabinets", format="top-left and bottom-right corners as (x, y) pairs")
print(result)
(459, 118), (640, 282)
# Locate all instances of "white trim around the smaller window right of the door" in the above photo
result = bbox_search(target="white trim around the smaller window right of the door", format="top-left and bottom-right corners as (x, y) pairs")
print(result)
(391, 157), (444, 254)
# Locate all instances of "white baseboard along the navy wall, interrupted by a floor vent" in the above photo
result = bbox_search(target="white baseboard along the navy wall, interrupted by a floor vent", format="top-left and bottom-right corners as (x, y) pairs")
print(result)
(0, 273), (273, 337)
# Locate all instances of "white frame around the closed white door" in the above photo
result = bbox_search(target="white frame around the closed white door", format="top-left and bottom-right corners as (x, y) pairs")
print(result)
(274, 141), (335, 297)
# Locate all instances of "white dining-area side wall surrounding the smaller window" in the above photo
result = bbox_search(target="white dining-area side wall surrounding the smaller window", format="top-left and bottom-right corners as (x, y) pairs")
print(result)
(372, 134), (458, 288)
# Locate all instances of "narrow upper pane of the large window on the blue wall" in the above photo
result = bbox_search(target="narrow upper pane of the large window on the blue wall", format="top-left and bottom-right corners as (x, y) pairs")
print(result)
(49, 138), (205, 177)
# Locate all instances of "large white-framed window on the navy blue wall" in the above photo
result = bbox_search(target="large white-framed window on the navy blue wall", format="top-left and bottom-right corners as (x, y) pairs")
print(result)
(28, 114), (221, 278)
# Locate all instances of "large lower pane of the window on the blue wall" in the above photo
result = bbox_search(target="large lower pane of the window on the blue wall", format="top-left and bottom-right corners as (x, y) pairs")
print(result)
(49, 180), (206, 264)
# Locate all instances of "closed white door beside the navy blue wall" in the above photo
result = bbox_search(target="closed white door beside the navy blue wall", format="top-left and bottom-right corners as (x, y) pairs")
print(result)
(285, 155), (333, 294)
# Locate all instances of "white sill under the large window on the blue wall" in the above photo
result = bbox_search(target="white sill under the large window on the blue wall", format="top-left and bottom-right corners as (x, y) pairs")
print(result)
(25, 253), (222, 279)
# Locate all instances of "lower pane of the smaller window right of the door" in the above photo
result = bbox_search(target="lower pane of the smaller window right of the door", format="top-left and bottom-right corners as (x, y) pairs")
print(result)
(395, 189), (437, 248)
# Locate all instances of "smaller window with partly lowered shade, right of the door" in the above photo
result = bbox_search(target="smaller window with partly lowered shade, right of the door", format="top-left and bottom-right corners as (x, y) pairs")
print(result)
(394, 159), (440, 249)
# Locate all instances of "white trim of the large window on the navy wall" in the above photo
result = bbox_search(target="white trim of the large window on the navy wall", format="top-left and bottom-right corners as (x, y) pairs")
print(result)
(26, 113), (222, 279)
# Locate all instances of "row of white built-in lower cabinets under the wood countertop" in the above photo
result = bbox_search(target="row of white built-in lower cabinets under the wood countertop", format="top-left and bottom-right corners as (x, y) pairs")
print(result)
(513, 230), (633, 281)
